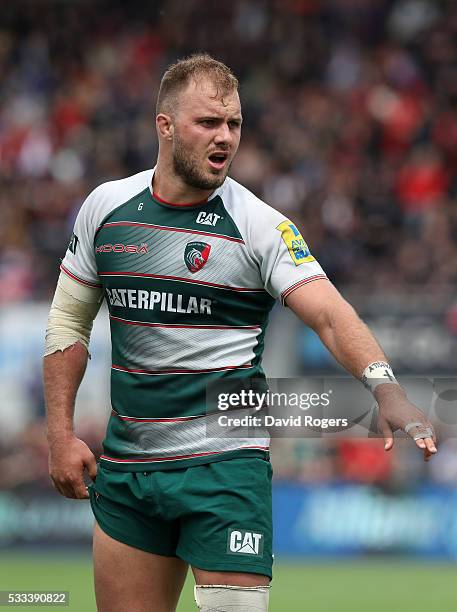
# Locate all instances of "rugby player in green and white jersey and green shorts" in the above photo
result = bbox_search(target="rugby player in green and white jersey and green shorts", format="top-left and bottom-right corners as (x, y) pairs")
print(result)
(44, 54), (436, 612)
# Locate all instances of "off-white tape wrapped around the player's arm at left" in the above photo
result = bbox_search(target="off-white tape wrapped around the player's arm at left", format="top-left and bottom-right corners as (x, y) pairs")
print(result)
(44, 272), (103, 356)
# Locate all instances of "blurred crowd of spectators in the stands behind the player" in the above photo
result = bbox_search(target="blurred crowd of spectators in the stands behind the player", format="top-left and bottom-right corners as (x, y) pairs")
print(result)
(0, 0), (457, 488)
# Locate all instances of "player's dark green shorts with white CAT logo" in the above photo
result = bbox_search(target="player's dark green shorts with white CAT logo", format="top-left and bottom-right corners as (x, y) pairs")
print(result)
(89, 458), (272, 578)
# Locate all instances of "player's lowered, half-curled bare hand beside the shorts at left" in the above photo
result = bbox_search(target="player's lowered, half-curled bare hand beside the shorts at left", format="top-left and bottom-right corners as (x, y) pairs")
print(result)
(49, 436), (97, 499)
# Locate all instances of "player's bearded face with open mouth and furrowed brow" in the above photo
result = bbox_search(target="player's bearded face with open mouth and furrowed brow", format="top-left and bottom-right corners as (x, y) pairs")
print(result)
(172, 79), (241, 190)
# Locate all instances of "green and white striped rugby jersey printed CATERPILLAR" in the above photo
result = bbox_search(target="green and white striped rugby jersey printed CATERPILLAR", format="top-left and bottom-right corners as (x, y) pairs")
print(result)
(61, 170), (326, 471)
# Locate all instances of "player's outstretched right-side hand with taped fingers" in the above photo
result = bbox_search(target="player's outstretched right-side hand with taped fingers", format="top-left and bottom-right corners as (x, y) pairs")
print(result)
(374, 383), (437, 461)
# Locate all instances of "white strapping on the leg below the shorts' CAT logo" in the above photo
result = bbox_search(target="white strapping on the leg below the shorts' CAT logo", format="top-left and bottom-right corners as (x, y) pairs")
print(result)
(194, 584), (270, 612)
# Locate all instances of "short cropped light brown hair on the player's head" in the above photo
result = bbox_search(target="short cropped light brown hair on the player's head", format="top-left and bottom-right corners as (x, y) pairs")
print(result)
(156, 53), (239, 114)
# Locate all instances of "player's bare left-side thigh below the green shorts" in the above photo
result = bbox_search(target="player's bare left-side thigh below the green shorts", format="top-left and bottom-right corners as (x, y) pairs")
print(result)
(93, 523), (187, 612)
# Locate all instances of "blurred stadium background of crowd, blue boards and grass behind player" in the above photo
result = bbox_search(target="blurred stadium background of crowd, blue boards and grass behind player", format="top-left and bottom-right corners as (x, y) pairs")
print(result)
(0, 0), (457, 612)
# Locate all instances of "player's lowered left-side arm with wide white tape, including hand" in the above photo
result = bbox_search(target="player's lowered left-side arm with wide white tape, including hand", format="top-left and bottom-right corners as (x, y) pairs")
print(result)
(43, 276), (100, 499)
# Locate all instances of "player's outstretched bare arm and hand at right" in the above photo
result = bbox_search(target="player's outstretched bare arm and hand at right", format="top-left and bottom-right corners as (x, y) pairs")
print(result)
(286, 280), (436, 461)
